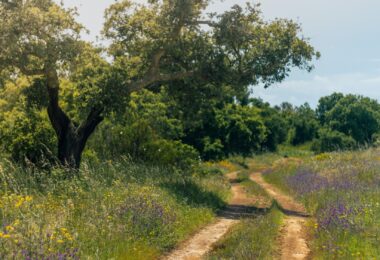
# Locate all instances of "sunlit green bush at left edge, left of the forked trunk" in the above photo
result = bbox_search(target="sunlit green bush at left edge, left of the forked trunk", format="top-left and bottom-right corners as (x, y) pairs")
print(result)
(0, 79), (56, 166)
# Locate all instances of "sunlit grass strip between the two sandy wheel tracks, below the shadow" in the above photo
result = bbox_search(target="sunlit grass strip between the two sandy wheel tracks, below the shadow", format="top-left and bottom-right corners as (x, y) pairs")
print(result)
(207, 207), (283, 260)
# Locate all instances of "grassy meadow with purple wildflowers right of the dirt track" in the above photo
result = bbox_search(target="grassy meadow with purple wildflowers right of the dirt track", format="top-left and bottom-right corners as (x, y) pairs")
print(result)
(265, 149), (380, 259)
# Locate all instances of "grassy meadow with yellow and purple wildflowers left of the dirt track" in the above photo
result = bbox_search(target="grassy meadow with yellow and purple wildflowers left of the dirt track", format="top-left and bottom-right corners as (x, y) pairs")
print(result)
(0, 160), (229, 259)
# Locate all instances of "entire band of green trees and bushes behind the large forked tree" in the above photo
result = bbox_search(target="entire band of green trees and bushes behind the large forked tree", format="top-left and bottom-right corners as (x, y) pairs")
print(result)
(0, 73), (380, 168)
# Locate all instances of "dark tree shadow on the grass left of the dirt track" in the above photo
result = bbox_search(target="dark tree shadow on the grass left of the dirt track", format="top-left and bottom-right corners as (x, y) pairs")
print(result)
(161, 180), (226, 211)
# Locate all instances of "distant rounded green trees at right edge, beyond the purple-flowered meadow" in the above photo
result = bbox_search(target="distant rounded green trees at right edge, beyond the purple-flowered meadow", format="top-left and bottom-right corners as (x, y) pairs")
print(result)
(276, 93), (380, 153)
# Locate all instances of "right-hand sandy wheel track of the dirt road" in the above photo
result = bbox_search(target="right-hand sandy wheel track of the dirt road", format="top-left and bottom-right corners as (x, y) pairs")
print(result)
(251, 173), (310, 260)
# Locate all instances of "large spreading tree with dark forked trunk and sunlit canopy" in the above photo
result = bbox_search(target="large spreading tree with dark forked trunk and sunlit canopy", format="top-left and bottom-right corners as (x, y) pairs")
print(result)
(0, 0), (319, 168)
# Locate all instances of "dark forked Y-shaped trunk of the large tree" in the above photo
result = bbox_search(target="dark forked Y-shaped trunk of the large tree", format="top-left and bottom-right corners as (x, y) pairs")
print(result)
(46, 70), (103, 169)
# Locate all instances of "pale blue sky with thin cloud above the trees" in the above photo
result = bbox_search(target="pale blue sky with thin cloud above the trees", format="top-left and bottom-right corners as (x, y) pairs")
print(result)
(60, 0), (380, 106)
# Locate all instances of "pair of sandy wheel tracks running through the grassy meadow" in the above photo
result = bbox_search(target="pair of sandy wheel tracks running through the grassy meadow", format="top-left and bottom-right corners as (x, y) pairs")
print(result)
(163, 172), (310, 260)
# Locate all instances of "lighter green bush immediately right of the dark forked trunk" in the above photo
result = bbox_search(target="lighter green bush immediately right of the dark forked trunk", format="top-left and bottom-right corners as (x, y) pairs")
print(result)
(86, 90), (199, 168)
